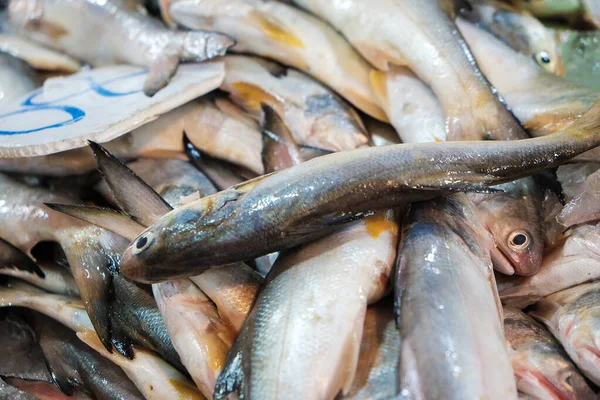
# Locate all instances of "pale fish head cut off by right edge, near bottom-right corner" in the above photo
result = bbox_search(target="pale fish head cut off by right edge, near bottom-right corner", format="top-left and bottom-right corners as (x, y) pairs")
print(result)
(529, 282), (600, 385)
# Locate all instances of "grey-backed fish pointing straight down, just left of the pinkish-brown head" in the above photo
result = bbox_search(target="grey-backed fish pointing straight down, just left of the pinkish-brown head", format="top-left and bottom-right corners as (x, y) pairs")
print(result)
(395, 195), (517, 399)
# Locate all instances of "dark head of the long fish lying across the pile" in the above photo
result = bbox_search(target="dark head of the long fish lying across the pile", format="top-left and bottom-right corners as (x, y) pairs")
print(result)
(120, 195), (230, 283)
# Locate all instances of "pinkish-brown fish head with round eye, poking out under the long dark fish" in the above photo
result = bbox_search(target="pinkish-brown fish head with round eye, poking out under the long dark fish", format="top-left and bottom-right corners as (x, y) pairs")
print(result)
(469, 177), (544, 275)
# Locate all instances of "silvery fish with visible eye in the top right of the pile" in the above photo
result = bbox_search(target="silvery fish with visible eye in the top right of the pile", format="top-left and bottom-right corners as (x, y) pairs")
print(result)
(461, 0), (565, 76)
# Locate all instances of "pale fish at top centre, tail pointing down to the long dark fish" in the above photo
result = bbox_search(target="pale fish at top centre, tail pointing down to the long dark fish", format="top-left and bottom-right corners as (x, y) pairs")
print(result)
(294, 0), (523, 140)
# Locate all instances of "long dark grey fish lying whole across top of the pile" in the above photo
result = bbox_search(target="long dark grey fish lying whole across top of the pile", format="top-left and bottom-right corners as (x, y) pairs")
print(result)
(121, 99), (600, 282)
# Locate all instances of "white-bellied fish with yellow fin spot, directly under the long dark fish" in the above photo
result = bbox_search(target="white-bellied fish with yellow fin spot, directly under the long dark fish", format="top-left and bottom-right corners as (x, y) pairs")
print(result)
(215, 212), (398, 399)
